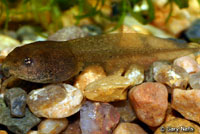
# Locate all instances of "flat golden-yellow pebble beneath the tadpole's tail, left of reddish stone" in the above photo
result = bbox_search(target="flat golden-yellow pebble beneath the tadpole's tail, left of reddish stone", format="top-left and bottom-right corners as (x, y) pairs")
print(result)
(84, 75), (130, 102)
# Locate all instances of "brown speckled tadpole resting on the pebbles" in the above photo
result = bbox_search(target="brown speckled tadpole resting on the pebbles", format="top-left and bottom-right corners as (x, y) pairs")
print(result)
(2, 33), (200, 83)
